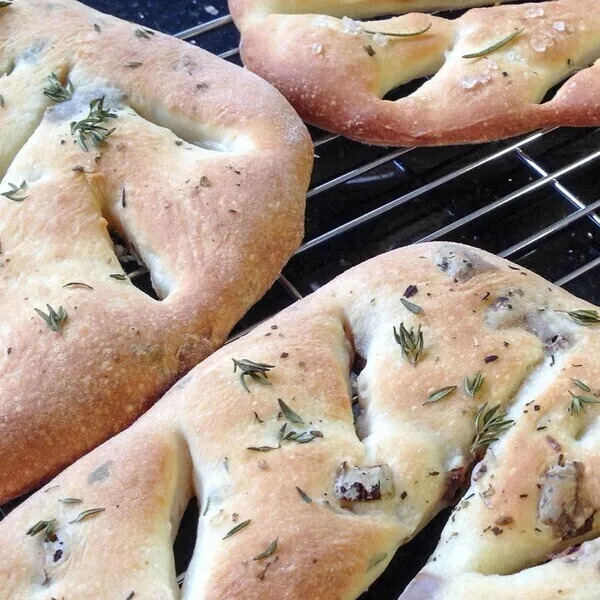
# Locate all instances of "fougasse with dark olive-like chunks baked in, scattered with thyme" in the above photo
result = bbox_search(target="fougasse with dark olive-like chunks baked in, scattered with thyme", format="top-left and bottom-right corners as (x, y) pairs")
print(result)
(0, 243), (600, 600)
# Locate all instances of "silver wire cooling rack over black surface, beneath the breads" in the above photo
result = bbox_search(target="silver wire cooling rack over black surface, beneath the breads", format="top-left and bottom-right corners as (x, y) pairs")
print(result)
(0, 0), (600, 600)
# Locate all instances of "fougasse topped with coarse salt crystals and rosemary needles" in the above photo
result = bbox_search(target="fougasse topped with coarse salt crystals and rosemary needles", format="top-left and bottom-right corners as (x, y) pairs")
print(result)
(230, 0), (600, 146)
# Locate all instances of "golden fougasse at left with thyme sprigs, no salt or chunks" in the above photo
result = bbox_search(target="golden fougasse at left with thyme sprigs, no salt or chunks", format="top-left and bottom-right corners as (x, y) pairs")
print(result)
(0, 0), (312, 502)
